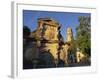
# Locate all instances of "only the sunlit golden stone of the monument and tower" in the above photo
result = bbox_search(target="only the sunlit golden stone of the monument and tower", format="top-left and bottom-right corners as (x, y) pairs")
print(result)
(28, 18), (73, 64)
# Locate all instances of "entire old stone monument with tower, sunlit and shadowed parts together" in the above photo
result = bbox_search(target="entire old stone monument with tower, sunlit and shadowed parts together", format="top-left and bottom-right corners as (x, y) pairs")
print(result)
(24, 18), (88, 67)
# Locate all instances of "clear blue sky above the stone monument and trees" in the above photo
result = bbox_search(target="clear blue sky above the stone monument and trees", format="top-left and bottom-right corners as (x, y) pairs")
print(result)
(23, 10), (91, 40)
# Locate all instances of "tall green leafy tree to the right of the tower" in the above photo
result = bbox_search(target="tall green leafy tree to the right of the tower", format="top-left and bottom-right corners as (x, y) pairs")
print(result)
(76, 16), (91, 56)
